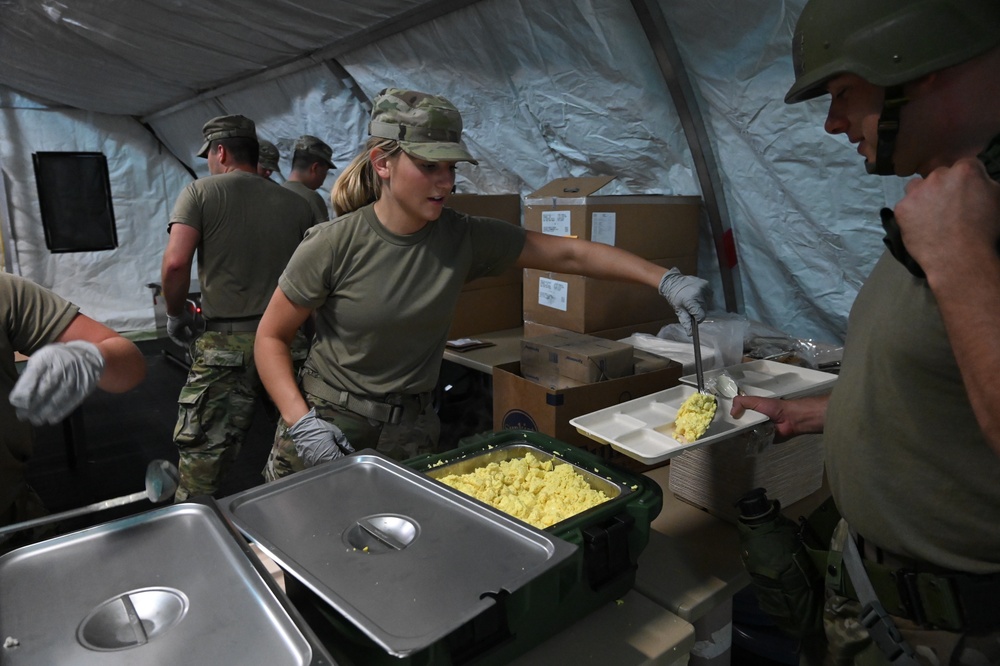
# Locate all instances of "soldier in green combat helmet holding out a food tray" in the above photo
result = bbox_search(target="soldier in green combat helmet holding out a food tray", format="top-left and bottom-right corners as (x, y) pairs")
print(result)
(733, 0), (1000, 665)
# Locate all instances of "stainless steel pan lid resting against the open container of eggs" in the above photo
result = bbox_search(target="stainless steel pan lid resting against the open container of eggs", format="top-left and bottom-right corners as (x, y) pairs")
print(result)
(220, 451), (576, 656)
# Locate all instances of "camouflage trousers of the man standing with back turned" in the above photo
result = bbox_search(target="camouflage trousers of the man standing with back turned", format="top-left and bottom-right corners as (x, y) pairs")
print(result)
(174, 331), (263, 502)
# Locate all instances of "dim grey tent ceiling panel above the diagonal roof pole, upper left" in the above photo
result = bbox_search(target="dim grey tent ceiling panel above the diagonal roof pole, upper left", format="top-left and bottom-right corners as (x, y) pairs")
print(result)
(0, 0), (460, 116)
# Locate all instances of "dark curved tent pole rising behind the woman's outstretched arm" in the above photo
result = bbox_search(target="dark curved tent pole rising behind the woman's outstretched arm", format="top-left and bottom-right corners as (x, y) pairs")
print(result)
(632, 0), (743, 312)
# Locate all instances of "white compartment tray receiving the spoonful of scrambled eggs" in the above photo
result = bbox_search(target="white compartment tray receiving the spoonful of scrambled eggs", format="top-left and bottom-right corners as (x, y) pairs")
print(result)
(570, 384), (767, 465)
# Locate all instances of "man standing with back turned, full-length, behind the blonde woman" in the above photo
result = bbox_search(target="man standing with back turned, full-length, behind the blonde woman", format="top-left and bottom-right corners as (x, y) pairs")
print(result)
(162, 115), (313, 502)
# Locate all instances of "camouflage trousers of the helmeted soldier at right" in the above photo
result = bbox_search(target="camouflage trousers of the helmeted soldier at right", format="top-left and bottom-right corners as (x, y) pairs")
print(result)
(799, 521), (1000, 666)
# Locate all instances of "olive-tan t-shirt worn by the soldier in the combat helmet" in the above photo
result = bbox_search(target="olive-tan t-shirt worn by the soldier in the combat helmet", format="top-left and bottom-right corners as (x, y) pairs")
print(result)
(823, 253), (1000, 573)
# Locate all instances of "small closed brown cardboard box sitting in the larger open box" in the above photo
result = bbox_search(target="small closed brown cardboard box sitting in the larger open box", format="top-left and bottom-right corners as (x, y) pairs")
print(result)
(521, 332), (634, 383)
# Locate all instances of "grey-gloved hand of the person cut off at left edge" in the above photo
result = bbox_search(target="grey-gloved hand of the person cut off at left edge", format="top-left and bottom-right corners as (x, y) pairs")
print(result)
(10, 340), (104, 425)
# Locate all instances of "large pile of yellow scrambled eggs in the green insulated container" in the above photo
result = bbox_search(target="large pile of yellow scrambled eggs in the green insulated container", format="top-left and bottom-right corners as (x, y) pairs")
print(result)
(438, 452), (610, 529)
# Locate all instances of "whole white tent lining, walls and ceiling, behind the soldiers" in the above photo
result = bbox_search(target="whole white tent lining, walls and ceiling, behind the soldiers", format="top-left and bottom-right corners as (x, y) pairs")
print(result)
(0, 0), (902, 342)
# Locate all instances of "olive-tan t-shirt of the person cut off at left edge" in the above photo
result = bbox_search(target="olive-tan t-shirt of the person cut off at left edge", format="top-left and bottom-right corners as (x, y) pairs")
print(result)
(0, 272), (79, 515)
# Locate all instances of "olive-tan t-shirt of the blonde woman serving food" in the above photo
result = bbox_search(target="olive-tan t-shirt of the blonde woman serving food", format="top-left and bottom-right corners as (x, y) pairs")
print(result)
(278, 204), (525, 398)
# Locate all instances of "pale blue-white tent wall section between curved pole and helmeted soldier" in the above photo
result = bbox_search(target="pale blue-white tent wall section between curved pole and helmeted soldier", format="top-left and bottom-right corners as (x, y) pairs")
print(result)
(661, 0), (902, 342)
